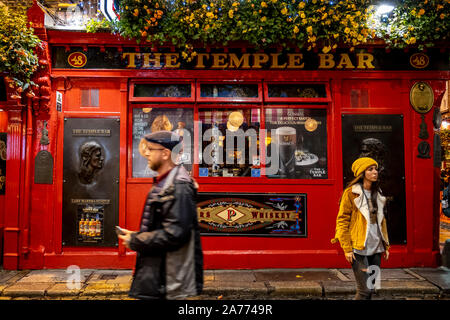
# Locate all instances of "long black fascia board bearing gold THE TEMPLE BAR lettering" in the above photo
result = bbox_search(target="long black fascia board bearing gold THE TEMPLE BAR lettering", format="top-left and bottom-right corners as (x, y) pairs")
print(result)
(52, 46), (450, 71)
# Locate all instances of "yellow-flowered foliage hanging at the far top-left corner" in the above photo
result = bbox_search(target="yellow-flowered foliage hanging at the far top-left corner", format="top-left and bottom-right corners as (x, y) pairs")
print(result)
(0, 4), (41, 97)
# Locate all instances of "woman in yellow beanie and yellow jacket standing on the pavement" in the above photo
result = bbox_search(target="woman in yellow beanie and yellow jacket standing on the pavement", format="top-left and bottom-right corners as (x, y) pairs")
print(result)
(331, 157), (389, 300)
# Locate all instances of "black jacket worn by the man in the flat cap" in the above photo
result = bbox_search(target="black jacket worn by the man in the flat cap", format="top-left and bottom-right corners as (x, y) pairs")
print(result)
(129, 166), (203, 299)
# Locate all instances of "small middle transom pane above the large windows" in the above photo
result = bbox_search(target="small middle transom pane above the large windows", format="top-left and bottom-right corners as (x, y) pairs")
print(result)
(200, 84), (258, 98)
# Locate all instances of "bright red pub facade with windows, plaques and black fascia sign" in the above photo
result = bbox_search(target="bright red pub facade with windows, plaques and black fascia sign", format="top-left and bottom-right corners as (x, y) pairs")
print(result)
(0, 5), (450, 269)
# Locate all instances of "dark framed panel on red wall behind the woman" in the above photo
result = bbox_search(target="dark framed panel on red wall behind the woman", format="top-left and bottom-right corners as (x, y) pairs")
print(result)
(342, 114), (406, 244)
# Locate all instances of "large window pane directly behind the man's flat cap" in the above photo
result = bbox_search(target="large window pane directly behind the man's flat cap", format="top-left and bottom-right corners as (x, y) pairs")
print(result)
(132, 108), (194, 178)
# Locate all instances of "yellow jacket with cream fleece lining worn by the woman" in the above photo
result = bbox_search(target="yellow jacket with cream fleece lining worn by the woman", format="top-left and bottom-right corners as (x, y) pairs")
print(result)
(331, 184), (389, 253)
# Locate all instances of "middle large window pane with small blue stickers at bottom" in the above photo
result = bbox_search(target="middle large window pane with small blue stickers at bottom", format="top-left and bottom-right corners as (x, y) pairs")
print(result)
(199, 108), (261, 177)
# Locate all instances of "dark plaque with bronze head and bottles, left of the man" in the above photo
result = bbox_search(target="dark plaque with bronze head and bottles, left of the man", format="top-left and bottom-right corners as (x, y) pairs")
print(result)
(62, 118), (120, 246)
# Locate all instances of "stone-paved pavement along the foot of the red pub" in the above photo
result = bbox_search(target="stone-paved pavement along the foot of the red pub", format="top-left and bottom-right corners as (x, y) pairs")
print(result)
(0, 267), (450, 300)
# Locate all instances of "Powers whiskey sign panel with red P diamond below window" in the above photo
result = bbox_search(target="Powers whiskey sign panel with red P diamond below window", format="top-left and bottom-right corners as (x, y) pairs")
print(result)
(197, 193), (307, 237)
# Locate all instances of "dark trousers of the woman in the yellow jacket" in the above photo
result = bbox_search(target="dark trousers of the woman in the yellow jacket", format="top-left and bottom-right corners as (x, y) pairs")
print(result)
(352, 253), (381, 300)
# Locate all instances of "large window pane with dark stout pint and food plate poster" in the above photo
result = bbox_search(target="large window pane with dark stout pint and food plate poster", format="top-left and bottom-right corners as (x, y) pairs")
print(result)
(266, 108), (328, 179)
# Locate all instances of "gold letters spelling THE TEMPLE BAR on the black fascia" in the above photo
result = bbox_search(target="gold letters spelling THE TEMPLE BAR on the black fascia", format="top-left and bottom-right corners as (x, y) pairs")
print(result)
(122, 52), (375, 69)
